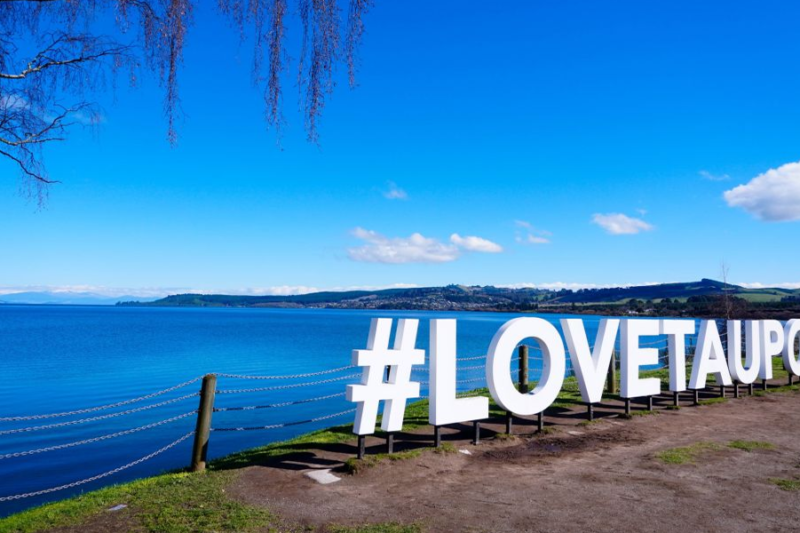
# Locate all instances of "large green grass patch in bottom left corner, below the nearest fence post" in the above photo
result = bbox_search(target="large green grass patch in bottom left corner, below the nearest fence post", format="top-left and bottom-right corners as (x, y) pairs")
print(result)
(0, 472), (275, 533)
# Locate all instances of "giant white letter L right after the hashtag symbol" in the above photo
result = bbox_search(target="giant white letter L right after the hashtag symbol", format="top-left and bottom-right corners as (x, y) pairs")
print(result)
(428, 319), (489, 426)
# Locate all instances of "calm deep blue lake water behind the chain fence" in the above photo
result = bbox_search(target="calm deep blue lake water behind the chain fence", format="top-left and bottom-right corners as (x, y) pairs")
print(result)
(0, 306), (664, 515)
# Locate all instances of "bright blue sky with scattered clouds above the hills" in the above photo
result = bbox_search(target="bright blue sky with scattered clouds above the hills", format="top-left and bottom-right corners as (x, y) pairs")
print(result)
(0, 0), (800, 295)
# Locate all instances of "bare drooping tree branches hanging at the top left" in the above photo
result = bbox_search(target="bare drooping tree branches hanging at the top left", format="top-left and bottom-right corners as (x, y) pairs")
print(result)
(0, 0), (372, 201)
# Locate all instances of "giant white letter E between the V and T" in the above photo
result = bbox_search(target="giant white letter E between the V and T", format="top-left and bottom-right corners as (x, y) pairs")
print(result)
(620, 320), (661, 398)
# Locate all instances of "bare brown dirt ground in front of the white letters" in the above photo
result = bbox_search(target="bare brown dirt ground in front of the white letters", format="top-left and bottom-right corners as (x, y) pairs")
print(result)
(229, 391), (800, 533)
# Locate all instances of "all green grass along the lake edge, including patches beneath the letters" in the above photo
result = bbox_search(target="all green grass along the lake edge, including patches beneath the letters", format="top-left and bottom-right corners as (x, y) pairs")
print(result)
(0, 359), (797, 533)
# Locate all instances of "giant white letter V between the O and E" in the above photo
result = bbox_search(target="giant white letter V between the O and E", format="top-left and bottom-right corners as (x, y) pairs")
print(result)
(561, 318), (619, 403)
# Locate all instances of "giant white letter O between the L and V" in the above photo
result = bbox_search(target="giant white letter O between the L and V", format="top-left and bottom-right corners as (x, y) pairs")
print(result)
(486, 317), (566, 416)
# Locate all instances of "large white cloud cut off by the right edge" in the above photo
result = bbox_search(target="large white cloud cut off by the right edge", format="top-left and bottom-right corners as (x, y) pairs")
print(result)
(723, 162), (800, 222)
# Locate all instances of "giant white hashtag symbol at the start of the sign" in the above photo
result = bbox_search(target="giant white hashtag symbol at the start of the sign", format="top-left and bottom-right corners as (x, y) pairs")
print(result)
(347, 318), (425, 435)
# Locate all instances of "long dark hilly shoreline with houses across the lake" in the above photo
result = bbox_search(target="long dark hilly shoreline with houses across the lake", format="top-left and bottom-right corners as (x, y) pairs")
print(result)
(119, 279), (800, 316)
